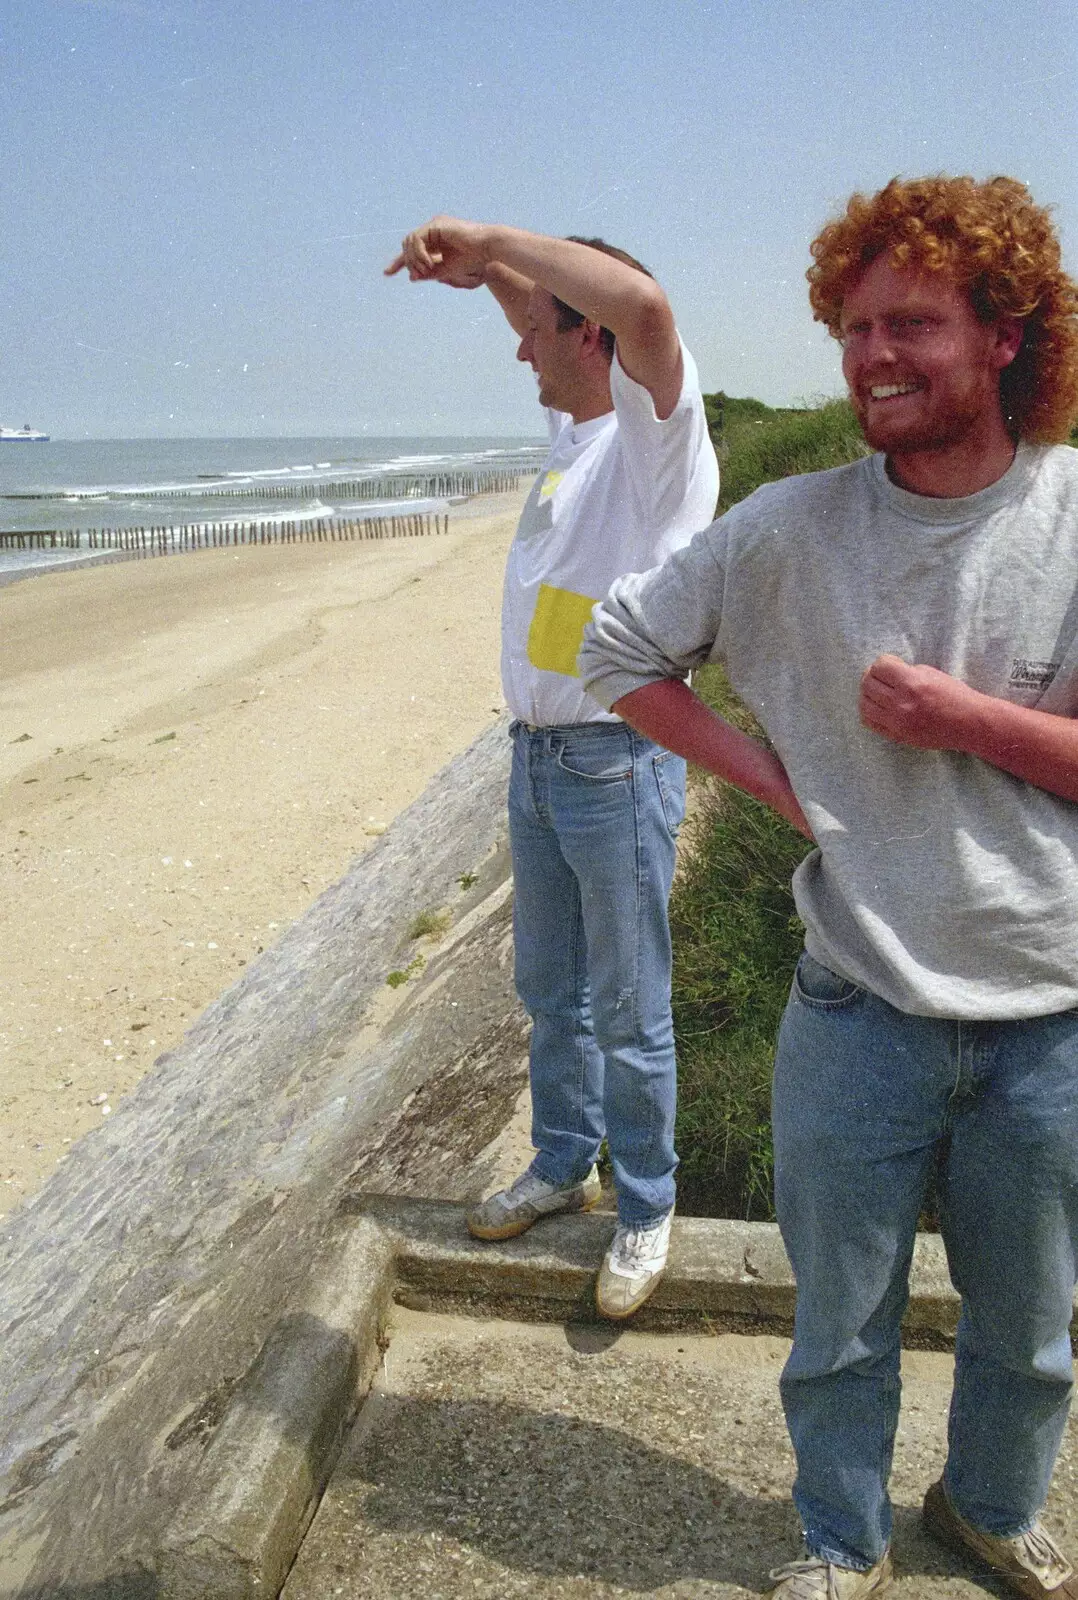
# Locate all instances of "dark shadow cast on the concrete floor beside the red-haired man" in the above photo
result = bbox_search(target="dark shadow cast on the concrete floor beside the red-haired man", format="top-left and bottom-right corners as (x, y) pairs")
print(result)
(302, 1395), (996, 1595)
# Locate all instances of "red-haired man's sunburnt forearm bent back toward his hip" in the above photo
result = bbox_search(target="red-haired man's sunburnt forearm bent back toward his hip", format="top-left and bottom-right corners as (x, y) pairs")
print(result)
(611, 678), (812, 838)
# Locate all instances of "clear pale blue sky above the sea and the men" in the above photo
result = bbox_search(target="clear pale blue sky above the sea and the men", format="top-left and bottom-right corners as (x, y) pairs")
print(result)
(0, 0), (1078, 438)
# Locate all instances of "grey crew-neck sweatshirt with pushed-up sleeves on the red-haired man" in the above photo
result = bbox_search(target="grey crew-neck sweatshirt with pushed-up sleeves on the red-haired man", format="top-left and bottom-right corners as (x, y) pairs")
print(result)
(579, 445), (1078, 1019)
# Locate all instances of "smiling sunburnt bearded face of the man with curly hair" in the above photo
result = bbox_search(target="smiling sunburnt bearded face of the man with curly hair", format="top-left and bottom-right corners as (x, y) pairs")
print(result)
(841, 256), (1020, 493)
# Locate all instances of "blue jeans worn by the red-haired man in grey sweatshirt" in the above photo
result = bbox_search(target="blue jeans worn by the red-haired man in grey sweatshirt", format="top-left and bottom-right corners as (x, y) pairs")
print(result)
(774, 954), (1078, 1568)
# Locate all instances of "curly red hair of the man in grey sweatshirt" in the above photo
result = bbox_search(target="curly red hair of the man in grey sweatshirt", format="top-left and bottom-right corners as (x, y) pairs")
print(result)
(806, 176), (1078, 445)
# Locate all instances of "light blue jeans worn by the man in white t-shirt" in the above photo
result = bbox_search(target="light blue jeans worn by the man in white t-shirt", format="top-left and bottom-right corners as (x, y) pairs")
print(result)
(509, 722), (685, 1227)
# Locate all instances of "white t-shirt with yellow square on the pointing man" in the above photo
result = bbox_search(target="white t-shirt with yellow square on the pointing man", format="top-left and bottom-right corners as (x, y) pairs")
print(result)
(502, 346), (718, 726)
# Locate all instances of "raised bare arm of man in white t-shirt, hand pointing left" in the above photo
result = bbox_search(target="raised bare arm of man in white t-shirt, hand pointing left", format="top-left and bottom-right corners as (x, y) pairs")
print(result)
(385, 216), (681, 418)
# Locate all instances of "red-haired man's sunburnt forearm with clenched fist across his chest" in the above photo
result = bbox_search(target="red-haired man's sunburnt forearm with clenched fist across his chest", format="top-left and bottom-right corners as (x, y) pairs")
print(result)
(859, 656), (1078, 802)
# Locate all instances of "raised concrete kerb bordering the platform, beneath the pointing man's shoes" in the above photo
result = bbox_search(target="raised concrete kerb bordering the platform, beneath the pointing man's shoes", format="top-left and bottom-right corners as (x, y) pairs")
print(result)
(136, 1195), (1074, 1600)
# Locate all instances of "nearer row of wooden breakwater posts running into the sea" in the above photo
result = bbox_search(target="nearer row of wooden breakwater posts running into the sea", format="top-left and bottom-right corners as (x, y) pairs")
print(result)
(0, 512), (449, 555)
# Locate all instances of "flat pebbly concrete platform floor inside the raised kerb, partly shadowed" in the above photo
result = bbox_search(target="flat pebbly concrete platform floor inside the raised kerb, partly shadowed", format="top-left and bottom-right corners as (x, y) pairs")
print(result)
(283, 1299), (1078, 1600)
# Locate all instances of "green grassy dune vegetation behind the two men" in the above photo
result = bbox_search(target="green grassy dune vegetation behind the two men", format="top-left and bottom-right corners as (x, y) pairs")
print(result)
(670, 395), (865, 1218)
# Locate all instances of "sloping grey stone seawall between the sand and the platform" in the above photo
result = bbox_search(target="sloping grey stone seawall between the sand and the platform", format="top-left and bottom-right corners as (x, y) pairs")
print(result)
(0, 723), (525, 1600)
